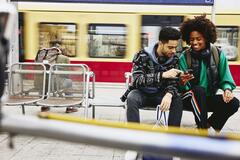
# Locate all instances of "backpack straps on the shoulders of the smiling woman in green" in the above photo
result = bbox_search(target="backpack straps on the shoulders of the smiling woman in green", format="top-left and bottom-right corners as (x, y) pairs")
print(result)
(186, 44), (220, 68)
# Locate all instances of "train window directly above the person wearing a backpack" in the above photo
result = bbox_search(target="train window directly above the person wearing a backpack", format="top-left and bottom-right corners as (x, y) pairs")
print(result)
(39, 23), (77, 57)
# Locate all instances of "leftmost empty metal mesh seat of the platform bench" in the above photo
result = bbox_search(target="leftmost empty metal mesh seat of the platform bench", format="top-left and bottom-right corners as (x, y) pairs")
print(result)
(4, 63), (46, 114)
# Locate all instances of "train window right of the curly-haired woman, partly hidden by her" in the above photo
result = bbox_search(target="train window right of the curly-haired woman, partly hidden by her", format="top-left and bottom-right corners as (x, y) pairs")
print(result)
(215, 26), (239, 61)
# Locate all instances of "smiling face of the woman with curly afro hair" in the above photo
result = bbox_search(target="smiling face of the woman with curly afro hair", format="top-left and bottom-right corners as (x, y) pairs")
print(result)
(190, 31), (206, 52)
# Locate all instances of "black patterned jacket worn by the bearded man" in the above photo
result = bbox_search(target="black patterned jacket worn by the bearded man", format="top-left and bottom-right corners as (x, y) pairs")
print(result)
(132, 47), (179, 95)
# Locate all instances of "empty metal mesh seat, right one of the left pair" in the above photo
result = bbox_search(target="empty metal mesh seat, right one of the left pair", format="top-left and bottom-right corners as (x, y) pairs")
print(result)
(37, 64), (95, 118)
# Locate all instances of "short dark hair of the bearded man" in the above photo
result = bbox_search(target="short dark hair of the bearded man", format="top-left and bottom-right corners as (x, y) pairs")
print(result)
(158, 27), (181, 43)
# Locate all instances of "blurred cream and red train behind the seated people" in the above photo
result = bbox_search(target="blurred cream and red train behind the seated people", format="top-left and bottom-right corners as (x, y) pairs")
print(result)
(15, 0), (240, 85)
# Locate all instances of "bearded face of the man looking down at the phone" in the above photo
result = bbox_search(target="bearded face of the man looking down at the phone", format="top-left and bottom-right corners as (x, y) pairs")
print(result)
(157, 40), (178, 58)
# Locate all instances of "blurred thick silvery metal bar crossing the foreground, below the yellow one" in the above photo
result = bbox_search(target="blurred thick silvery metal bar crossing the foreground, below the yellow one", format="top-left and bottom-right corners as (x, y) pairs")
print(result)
(0, 114), (240, 160)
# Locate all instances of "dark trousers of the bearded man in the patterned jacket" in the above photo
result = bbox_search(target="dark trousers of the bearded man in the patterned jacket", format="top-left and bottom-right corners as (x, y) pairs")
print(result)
(127, 89), (182, 126)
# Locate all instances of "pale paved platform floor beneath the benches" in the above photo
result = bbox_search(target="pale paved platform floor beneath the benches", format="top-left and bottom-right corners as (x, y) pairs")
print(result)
(0, 84), (240, 160)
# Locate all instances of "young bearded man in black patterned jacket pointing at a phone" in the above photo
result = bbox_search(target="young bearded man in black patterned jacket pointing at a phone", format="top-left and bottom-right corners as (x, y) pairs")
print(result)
(127, 27), (182, 126)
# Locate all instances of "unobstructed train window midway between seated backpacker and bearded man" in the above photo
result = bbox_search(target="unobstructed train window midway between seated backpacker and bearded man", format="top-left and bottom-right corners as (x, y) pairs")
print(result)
(88, 24), (126, 58)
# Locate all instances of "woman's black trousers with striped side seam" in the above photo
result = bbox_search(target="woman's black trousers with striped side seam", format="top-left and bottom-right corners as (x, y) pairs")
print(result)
(183, 86), (239, 131)
